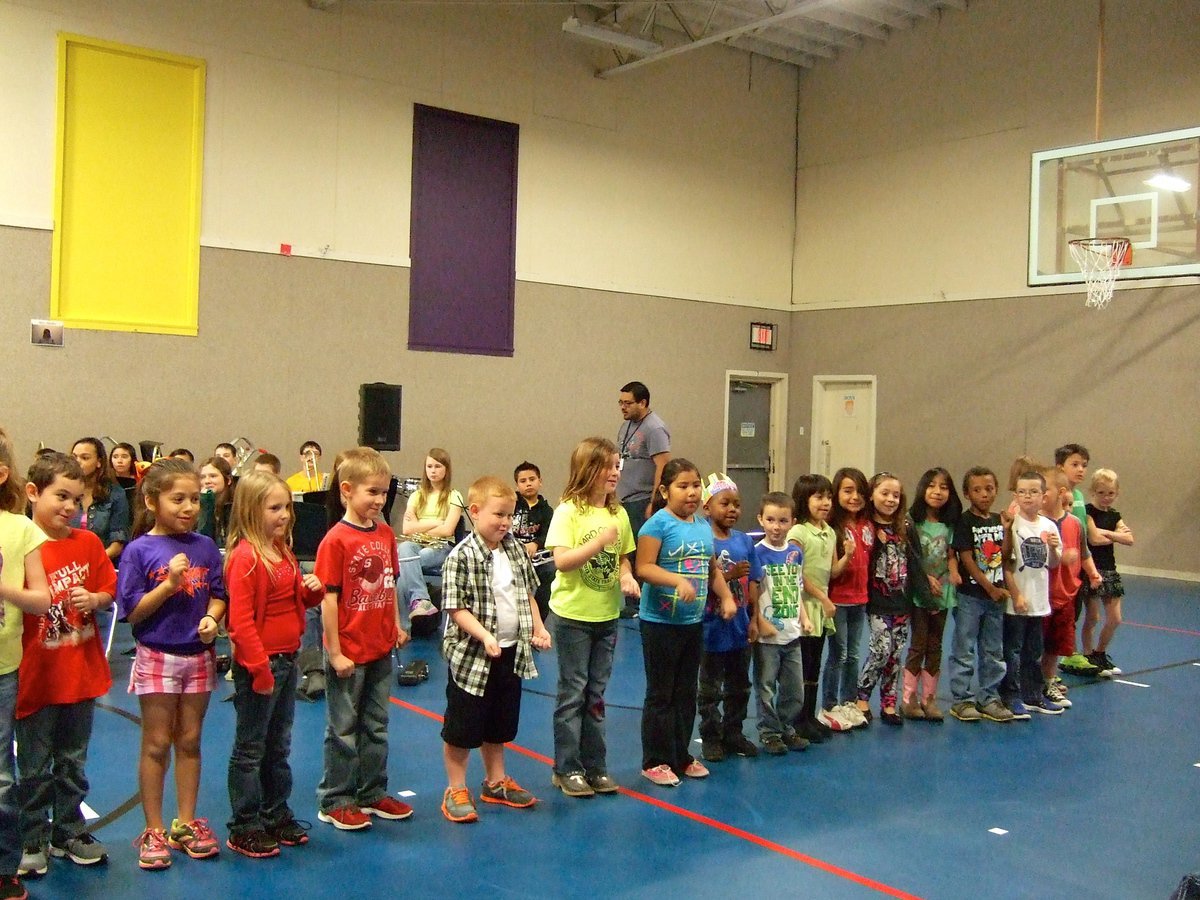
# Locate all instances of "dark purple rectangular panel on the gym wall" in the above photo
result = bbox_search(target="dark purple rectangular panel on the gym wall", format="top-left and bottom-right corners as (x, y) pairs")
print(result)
(408, 104), (518, 356)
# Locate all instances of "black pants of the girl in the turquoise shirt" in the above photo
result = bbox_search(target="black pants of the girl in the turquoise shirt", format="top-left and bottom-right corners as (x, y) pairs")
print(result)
(640, 619), (704, 778)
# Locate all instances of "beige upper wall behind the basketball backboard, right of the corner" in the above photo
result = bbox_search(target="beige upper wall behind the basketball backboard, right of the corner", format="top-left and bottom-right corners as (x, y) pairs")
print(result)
(796, 0), (1200, 308)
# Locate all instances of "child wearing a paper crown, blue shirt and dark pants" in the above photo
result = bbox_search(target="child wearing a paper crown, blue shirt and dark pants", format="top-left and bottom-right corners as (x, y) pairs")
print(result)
(697, 473), (758, 762)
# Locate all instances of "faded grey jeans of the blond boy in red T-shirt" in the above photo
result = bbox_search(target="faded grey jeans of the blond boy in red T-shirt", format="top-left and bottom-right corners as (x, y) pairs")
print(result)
(317, 653), (391, 812)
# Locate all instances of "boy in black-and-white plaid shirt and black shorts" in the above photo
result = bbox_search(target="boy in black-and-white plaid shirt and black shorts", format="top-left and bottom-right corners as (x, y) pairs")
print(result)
(442, 475), (550, 822)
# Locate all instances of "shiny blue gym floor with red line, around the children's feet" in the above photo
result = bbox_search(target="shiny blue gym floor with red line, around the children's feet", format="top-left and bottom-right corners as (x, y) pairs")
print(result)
(37, 577), (1200, 900)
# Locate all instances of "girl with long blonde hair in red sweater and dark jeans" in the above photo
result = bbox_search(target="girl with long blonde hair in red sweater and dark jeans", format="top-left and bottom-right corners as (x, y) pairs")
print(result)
(226, 472), (324, 859)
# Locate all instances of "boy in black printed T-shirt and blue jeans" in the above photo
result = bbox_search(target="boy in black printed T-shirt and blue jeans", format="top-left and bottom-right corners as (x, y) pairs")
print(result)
(950, 466), (1013, 722)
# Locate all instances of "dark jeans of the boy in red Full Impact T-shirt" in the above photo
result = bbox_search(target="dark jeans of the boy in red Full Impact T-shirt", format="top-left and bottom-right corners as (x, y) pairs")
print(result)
(17, 700), (96, 847)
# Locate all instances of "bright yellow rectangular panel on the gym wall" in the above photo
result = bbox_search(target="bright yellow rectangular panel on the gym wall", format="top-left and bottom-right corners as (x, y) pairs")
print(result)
(50, 35), (204, 335)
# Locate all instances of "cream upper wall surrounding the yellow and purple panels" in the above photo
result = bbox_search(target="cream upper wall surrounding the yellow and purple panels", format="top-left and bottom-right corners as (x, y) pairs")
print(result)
(0, 0), (796, 308)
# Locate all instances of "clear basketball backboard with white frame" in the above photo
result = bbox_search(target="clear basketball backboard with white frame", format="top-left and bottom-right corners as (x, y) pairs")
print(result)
(1028, 127), (1200, 284)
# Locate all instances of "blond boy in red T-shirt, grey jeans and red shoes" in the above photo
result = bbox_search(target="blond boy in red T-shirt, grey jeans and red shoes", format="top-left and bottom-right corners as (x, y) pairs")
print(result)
(316, 446), (413, 830)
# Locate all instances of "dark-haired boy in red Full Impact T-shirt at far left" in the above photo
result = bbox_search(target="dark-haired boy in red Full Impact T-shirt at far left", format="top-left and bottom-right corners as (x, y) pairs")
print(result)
(17, 454), (116, 876)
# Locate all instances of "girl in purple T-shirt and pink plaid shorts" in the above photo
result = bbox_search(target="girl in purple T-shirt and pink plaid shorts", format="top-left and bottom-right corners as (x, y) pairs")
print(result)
(116, 460), (226, 869)
